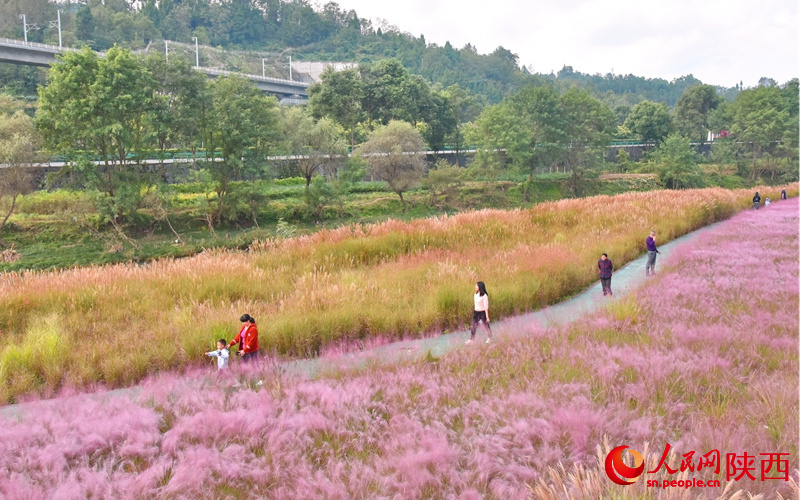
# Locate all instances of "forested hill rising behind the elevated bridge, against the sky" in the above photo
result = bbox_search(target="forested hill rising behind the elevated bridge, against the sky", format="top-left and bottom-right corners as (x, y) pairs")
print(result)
(0, 0), (738, 106)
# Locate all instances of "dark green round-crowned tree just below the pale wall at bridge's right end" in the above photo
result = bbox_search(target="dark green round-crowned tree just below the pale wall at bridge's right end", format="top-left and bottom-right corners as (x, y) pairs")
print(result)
(308, 67), (364, 147)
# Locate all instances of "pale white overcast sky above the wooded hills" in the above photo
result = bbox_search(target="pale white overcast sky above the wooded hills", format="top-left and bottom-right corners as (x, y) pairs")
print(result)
(330, 0), (798, 87)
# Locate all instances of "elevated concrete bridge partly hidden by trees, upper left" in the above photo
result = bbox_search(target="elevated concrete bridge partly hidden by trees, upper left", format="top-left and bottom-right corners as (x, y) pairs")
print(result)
(0, 38), (309, 99)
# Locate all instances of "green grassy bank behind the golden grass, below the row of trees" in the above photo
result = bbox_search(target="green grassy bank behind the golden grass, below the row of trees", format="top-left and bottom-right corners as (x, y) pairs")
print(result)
(0, 174), (657, 272)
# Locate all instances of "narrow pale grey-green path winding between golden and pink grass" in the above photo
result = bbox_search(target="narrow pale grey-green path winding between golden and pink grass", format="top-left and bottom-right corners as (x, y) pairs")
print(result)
(0, 198), (798, 419)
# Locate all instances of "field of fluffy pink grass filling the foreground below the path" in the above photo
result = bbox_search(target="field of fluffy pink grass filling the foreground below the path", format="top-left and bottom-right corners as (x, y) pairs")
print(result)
(0, 198), (799, 500)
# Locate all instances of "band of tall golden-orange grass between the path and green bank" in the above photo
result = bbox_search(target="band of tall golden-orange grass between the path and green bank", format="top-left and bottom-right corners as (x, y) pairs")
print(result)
(0, 185), (798, 401)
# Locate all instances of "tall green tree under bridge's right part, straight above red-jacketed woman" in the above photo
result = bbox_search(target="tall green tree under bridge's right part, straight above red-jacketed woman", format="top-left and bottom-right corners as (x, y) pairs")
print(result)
(204, 76), (278, 222)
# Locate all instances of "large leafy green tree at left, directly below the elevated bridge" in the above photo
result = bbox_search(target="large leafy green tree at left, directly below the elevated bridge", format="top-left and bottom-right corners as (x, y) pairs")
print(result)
(36, 47), (155, 222)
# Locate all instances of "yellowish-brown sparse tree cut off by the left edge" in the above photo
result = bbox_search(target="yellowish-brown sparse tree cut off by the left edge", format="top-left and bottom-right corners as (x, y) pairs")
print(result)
(0, 111), (40, 247)
